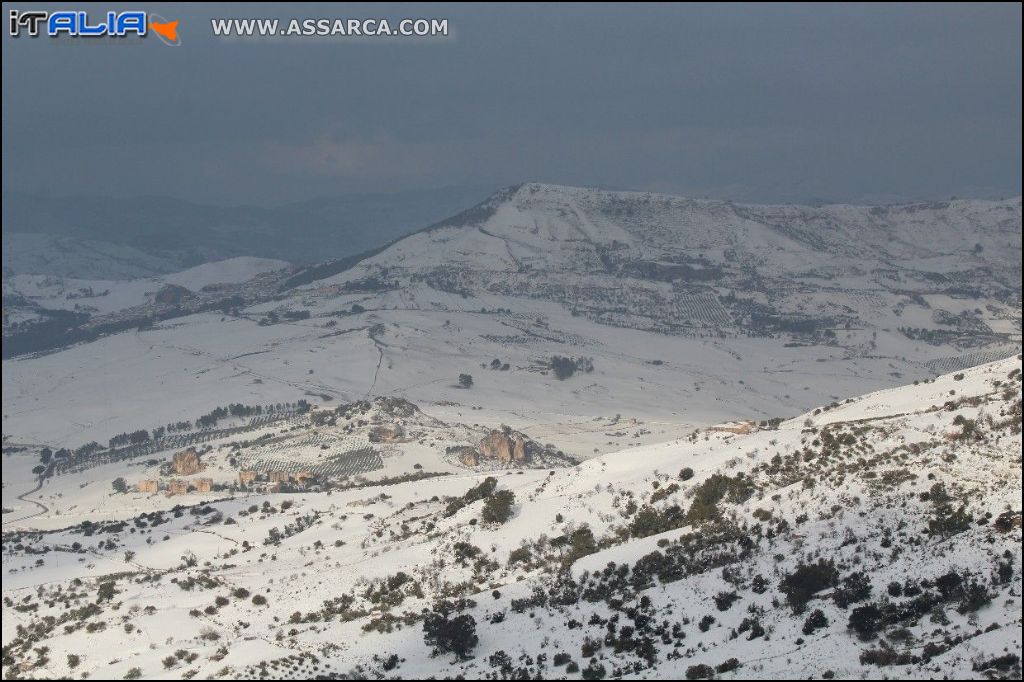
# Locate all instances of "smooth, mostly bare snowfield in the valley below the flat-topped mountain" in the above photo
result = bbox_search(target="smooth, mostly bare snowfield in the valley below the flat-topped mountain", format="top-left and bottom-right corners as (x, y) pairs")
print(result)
(3, 301), (944, 447)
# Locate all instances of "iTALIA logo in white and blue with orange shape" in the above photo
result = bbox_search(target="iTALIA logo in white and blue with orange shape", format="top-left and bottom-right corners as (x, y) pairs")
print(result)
(9, 9), (181, 46)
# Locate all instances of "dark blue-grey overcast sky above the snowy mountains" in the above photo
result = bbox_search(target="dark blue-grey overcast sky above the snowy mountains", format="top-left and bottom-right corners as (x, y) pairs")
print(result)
(3, 3), (1021, 205)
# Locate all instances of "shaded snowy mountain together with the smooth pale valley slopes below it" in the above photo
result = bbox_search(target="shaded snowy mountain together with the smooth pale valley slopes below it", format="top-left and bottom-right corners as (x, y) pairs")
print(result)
(3, 184), (1021, 455)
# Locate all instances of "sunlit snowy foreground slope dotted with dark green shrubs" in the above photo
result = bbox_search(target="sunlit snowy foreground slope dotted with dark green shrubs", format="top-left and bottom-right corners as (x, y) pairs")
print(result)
(3, 355), (1022, 679)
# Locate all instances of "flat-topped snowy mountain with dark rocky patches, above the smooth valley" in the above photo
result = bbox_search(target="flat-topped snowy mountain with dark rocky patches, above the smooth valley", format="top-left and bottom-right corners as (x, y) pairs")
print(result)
(315, 184), (1021, 342)
